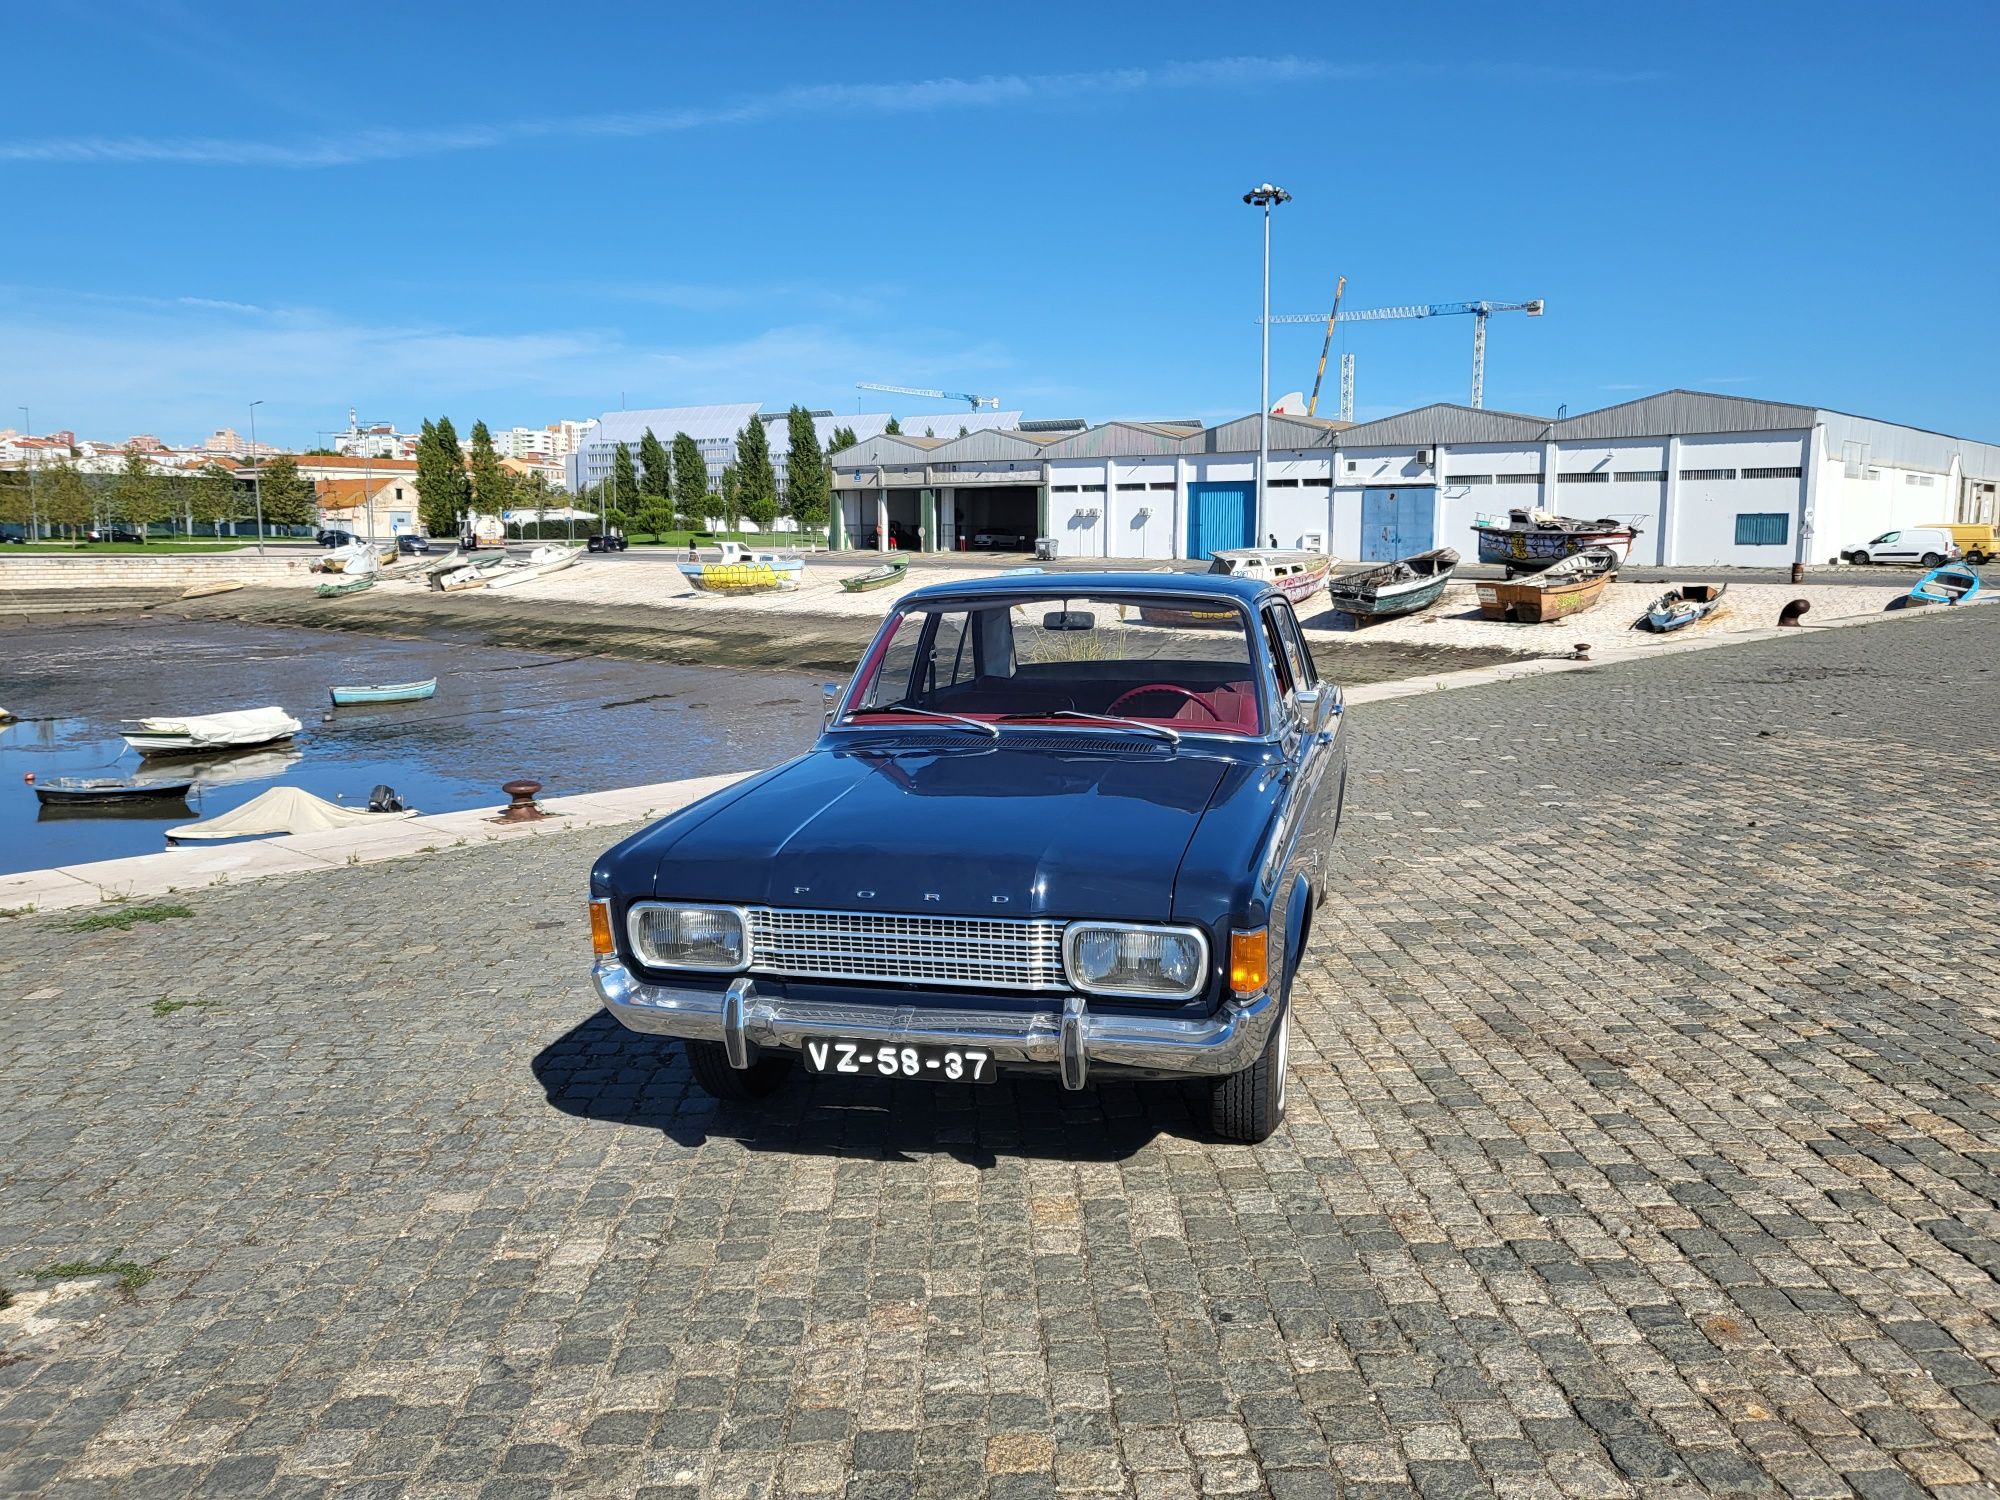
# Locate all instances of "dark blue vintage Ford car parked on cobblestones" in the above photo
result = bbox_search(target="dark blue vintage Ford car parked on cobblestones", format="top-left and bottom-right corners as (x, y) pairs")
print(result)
(590, 572), (1346, 1140)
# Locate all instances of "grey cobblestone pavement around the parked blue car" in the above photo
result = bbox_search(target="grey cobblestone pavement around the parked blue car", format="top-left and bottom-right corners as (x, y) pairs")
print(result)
(0, 610), (2000, 1498)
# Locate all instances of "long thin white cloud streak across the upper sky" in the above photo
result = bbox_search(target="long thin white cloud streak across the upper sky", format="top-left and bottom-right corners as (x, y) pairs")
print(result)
(0, 56), (1650, 168)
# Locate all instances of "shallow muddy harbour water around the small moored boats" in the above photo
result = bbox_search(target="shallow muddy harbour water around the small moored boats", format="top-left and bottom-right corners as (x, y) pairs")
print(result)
(0, 616), (822, 872)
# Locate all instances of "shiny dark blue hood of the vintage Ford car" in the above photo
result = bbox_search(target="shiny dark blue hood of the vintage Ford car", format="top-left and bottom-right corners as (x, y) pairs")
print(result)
(626, 746), (1230, 922)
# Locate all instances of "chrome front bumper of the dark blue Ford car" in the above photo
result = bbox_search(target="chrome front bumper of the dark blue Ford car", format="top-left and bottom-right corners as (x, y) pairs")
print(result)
(590, 958), (1278, 1088)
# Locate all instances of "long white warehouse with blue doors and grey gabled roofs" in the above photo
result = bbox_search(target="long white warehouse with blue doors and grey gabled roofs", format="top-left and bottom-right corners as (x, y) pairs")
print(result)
(832, 390), (2000, 566)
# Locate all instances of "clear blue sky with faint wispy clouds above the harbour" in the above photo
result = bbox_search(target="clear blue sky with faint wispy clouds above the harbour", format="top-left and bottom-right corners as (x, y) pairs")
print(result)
(0, 0), (2000, 446)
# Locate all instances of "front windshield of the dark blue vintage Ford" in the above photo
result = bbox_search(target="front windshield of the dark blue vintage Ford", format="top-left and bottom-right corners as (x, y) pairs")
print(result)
(844, 594), (1264, 734)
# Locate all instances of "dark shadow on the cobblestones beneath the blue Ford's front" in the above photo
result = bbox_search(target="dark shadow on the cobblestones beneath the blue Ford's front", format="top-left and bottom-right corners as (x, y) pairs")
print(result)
(530, 1010), (1212, 1168)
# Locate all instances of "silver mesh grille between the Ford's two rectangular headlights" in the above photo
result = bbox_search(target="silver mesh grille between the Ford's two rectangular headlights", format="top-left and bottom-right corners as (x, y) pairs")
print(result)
(750, 906), (1064, 990)
